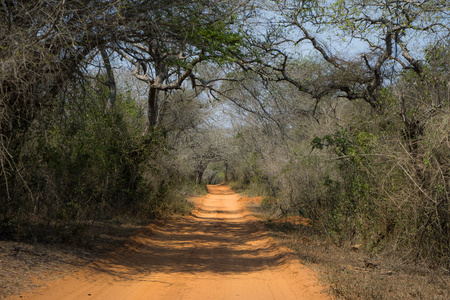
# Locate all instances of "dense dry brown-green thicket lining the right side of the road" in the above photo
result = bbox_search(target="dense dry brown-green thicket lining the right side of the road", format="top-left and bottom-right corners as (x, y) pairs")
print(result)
(223, 43), (450, 265)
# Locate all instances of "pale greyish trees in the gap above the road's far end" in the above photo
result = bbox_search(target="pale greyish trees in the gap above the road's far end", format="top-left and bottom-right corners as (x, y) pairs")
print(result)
(160, 91), (229, 185)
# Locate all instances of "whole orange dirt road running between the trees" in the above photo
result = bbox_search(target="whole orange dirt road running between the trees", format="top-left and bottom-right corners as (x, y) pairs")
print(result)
(12, 185), (328, 300)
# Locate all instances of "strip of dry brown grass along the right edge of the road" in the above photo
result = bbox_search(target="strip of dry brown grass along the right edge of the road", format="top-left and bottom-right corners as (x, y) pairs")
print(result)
(262, 211), (450, 299)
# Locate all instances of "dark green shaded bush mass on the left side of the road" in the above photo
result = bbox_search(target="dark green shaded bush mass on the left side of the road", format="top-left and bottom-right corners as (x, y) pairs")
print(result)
(0, 81), (189, 241)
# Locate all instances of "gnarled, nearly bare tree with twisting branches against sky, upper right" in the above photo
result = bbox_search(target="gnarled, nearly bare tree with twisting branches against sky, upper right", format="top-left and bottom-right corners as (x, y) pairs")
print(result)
(242, 0), (450, 109)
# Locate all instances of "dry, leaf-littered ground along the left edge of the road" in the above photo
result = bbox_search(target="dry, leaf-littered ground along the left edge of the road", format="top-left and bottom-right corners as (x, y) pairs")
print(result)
(0, 222), (143, 299)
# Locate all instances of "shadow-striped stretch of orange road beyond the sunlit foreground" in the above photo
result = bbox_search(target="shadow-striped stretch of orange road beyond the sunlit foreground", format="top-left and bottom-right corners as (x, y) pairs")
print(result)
(85, 186), (289, 280)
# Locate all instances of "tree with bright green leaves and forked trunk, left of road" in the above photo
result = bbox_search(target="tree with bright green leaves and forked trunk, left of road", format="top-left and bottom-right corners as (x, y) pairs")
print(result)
(110, 0), (246, 130)
